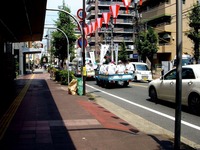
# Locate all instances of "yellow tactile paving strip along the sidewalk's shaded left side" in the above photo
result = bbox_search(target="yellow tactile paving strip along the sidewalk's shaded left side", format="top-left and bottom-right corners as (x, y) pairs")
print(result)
(0, 74), (35, 140)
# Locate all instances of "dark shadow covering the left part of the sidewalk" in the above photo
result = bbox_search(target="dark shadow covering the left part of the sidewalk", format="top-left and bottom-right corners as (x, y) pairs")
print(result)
(0, 72), (76, 150)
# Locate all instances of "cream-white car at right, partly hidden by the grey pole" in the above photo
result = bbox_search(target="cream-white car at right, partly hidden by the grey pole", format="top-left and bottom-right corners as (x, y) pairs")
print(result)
(148, 64), (200, 115)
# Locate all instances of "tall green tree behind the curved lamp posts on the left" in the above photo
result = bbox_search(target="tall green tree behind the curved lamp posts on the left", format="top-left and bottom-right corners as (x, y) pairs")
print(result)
(52, 4), (77, 66)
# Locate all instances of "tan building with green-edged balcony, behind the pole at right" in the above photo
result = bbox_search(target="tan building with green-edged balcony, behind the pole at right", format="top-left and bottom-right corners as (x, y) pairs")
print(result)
(139, 0), (197, 64)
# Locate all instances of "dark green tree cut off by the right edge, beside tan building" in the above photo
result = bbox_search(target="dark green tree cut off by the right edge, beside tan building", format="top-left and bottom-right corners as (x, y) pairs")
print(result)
(186, 3), (200, 63)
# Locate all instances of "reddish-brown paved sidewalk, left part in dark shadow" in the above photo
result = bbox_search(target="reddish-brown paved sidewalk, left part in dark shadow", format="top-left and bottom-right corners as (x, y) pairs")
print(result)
(0, 70), (195, 150)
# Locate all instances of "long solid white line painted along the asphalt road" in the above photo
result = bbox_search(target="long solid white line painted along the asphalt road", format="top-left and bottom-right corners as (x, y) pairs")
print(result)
(86, 84), (200, 130)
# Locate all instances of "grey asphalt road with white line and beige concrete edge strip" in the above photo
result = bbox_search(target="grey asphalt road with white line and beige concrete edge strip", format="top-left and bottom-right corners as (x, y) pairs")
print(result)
(86, 81), (200, 148)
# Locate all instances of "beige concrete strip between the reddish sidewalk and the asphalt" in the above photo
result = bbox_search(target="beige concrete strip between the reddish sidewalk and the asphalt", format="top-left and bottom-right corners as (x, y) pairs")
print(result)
(88, 93), (200, 149)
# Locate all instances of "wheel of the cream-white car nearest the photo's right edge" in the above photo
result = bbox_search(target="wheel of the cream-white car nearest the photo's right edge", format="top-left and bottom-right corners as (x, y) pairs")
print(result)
(188, 93), (200, 115)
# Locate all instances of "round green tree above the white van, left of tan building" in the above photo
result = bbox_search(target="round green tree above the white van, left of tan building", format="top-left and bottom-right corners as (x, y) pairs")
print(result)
(136, 27), (158, 69)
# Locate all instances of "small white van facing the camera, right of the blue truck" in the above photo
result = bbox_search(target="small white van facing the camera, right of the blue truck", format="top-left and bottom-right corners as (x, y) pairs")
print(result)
(132, 62), (152, 82)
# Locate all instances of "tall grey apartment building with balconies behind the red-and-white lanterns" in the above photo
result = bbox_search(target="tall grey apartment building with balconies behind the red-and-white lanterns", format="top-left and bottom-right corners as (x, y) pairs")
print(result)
(86, 0), (138, 60)
